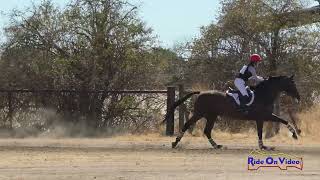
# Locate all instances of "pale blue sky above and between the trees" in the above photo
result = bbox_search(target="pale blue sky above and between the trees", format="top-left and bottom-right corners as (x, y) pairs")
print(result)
(0, 0), (220, 48)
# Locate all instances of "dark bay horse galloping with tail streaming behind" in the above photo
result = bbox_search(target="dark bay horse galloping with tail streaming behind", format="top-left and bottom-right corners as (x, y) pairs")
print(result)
(164, 76), (300, 150)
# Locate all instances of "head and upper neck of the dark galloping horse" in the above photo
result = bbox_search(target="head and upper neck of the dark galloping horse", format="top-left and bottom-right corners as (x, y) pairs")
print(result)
(268, 75), (300, 101)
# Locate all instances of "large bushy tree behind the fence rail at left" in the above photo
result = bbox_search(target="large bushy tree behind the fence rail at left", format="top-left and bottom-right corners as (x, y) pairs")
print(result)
(0, 0), (178, 133)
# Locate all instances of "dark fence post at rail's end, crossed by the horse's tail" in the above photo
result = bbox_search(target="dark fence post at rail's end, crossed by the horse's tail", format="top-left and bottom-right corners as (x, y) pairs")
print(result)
(166, 87), (176, 136)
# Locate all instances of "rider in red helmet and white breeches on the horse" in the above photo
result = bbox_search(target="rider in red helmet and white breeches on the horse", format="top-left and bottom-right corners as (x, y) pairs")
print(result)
(234, 54), (264, 110)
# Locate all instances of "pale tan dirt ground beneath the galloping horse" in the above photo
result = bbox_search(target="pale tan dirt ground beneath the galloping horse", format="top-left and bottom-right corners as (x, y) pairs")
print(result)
(0, 134), (320, 180)
